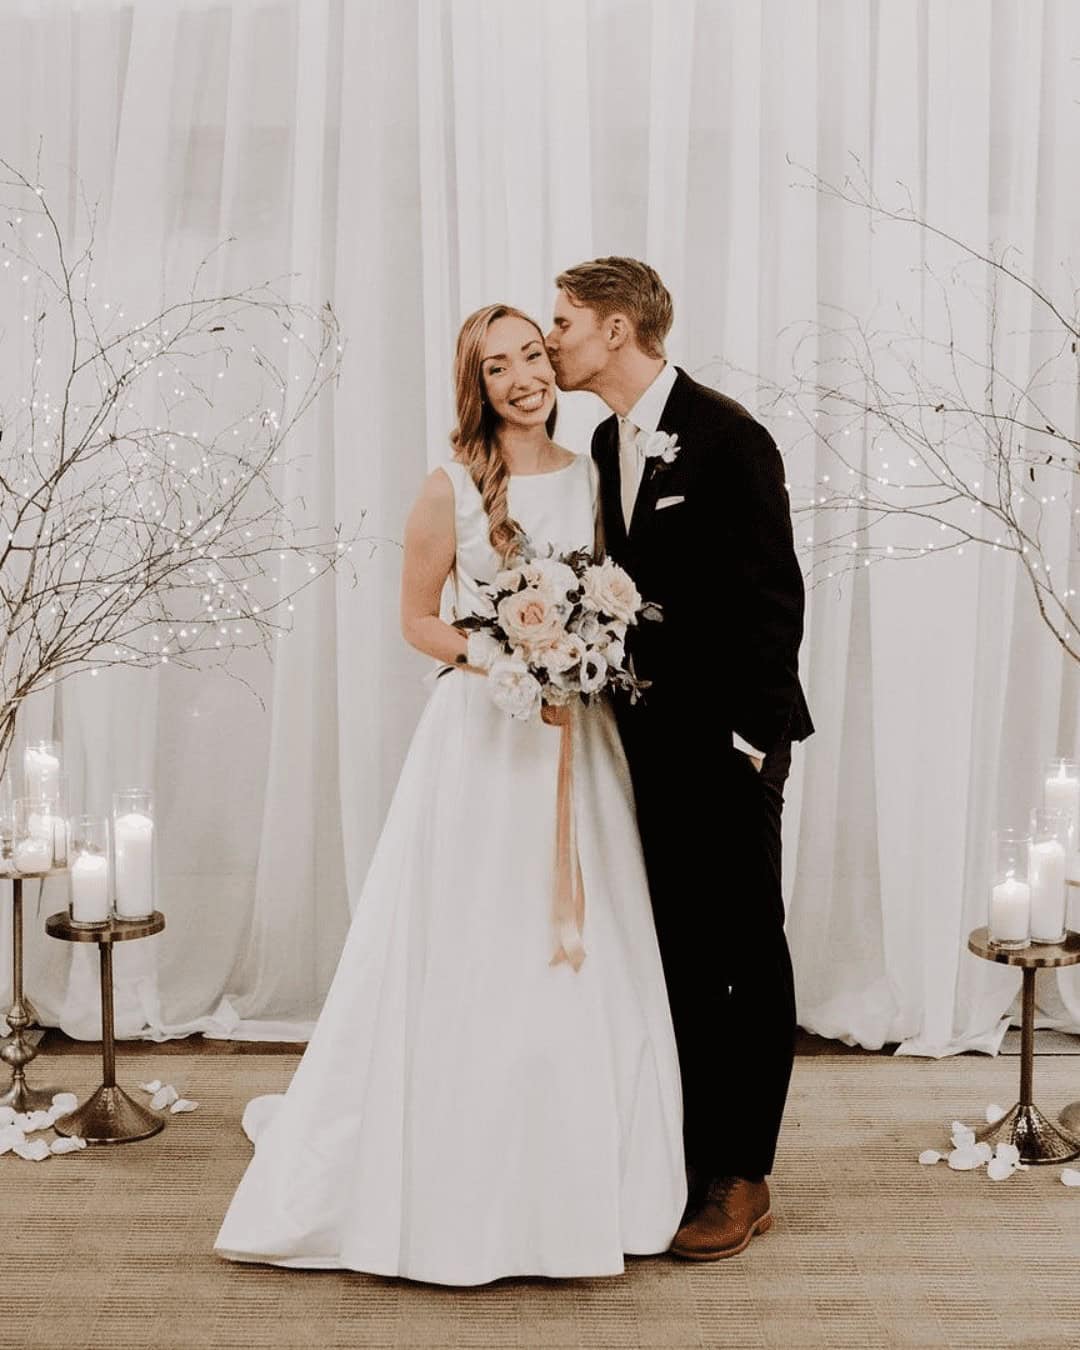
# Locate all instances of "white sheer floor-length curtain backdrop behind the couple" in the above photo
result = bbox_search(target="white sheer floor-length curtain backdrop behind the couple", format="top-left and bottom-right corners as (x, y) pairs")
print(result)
(0, 0), (1080, 1054)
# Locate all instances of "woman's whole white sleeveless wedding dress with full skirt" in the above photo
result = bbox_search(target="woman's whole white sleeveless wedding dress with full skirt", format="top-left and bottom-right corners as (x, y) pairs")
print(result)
(215, 456), (686, 1285)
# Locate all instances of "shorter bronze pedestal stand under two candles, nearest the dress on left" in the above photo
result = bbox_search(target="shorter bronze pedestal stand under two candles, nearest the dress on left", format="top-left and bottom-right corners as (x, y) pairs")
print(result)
(45, 910), (165, 1143)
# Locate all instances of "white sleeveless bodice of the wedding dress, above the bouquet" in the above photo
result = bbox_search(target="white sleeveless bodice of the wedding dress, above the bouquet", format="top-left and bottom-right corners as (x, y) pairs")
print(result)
(443, 455), (597, 618)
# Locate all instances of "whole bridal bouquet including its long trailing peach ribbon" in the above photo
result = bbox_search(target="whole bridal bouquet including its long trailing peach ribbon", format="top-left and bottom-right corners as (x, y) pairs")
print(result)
(455, 545), (662, 971)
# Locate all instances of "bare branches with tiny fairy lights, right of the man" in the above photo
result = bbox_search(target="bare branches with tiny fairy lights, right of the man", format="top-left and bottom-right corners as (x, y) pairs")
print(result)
(723, 163), (1080, 660)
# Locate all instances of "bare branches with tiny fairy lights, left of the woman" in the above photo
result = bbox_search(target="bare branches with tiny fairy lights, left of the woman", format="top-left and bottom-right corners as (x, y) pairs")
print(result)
(0, 161), (358, 774)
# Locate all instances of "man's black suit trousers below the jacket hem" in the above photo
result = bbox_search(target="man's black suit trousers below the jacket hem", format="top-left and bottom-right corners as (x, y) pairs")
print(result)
(618, 705), (795, 1177)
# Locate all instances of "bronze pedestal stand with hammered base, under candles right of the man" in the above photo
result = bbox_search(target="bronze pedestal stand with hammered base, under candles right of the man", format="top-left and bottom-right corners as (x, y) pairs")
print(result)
(968, 927), (1080, 1162)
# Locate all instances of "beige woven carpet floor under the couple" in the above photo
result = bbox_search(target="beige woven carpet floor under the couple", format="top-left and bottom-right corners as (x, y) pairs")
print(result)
(0, 1050), (1080, 1350)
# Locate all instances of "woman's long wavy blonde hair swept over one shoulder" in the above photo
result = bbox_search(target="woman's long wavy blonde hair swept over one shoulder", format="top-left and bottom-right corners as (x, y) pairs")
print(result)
(450, 305), (555, 560)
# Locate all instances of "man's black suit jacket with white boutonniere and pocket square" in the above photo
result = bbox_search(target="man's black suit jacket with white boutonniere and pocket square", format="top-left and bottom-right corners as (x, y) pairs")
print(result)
(593, 370), (814, 752)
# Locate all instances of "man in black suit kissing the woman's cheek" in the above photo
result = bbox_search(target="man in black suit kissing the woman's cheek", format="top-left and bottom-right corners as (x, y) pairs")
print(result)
(547, 258), (813, 1261)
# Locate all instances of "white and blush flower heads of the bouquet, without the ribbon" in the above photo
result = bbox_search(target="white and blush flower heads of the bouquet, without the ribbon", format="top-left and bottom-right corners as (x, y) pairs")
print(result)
(455, 549), (662, 720)
